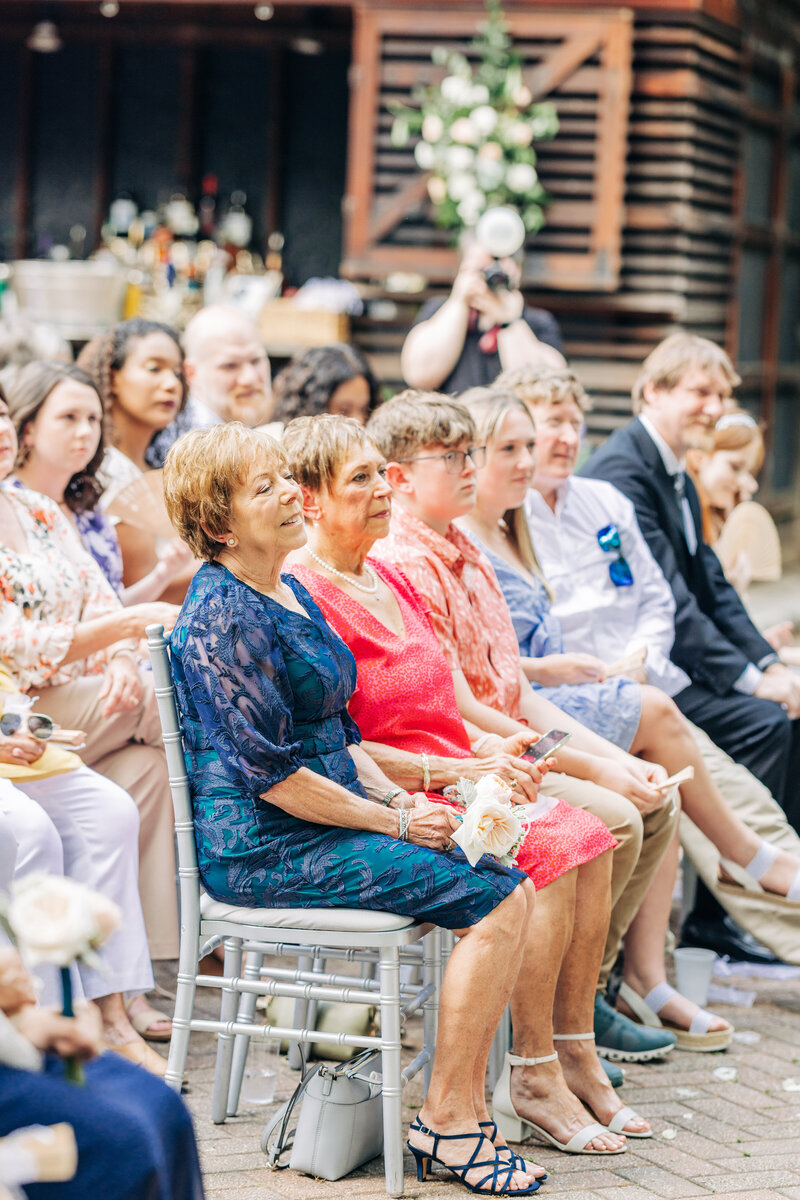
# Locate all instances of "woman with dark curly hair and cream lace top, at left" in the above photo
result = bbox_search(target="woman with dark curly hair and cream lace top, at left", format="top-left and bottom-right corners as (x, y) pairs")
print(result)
(78, 317), (194, 604)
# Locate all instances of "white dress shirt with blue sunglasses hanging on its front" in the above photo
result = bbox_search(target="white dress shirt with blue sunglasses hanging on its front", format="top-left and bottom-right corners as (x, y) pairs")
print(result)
(525, 476), (690, 696)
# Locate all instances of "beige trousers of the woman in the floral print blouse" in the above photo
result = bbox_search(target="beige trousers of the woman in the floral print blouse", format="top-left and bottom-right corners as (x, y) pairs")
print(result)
(36, 671), (178, 959)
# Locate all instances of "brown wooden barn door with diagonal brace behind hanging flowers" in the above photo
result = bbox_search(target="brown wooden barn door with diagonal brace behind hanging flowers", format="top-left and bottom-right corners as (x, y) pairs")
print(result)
(342, 7), (631, 290)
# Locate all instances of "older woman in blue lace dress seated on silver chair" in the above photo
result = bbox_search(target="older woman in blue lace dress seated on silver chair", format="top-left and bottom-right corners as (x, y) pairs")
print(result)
(164, 422), (551, 1195)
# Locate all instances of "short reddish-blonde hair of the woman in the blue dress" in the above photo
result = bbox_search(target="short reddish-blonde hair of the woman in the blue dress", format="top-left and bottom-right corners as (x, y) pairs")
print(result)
(163, 421), (288, 563)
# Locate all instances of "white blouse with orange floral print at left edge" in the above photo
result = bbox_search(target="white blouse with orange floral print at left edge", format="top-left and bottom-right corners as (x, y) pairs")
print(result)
(0, 482), (122, 691)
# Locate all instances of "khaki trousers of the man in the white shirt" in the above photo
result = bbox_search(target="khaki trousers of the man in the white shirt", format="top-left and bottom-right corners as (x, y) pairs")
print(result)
(680, 726), (800, 966)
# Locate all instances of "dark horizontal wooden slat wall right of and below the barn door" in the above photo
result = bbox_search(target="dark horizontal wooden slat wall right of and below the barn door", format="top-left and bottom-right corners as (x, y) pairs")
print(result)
(355, 13), (741, 451)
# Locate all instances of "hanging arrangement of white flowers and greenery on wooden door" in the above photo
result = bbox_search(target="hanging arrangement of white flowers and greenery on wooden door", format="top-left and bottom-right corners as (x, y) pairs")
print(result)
(392, 0), (559, 233)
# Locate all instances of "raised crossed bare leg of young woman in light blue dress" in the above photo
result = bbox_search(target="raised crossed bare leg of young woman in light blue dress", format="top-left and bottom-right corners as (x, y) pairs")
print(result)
(631, 686), (800, 895)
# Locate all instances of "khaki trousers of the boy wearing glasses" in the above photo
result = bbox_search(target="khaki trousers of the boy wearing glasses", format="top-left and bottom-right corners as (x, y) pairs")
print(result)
(541, 772), (679, 992)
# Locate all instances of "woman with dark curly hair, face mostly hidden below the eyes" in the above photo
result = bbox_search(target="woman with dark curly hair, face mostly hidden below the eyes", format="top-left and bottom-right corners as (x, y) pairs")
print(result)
(272, 342), (380, 425)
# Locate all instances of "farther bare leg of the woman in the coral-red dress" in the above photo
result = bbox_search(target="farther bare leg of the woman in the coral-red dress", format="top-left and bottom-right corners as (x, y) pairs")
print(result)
(555, 851), (650, 1133)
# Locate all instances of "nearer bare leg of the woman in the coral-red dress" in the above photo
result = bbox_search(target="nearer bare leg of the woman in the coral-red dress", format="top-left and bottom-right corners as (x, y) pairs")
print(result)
(511, 854), (625, 1151)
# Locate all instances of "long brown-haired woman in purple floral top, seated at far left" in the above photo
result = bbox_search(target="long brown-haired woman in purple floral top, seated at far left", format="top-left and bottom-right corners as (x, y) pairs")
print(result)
(7, 362), (186, 605)
